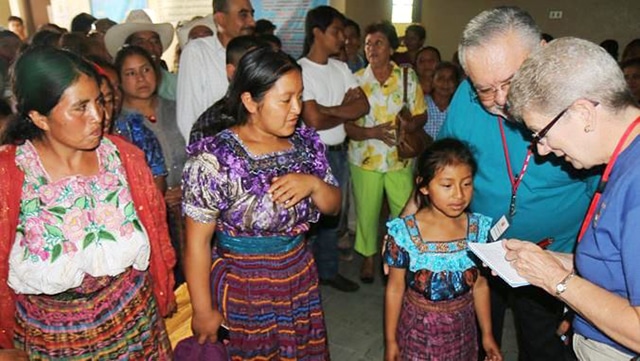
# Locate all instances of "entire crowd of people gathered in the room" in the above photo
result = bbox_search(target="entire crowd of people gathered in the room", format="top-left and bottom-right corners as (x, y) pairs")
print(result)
(0, 0), (640, 361)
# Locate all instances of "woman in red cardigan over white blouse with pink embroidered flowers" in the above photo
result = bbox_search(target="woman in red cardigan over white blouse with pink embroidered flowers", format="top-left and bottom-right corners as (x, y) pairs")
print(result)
(0, 48), (175, 360)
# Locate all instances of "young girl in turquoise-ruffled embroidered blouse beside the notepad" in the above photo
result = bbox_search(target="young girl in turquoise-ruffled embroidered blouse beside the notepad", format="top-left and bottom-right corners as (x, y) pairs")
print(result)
(383, 139), (502, 361)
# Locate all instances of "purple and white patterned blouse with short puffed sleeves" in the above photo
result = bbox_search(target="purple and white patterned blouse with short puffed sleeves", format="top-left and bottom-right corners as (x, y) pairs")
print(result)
(182, 127), (338, 236)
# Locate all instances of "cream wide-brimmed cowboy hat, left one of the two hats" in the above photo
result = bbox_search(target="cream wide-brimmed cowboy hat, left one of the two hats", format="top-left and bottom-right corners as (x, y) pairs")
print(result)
(104, 9), (173, 58)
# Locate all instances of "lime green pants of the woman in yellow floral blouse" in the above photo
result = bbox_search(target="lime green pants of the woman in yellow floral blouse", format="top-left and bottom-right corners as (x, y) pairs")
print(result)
(349, 164), (414, 257)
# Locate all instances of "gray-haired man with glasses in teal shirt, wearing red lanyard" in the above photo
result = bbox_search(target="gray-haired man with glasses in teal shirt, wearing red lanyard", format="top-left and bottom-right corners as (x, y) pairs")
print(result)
(438, 7), (598, 361)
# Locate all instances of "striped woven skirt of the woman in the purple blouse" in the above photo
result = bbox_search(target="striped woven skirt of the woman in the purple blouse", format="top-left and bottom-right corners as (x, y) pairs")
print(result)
(211, 235), (329, 361)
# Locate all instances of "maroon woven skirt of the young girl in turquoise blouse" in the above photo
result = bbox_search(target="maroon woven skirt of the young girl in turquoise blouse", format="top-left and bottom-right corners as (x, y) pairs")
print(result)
(396, 289), (478, 361)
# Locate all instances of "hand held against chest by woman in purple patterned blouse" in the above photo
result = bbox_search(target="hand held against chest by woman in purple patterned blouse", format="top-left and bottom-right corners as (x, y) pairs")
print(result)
(268, 173), (322, 208)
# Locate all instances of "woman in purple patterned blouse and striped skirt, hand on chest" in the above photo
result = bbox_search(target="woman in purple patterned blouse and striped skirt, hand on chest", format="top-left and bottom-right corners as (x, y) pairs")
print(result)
(183, 48), (340, 360)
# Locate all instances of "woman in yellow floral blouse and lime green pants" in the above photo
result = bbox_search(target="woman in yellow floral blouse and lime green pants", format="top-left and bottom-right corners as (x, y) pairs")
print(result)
(345, 22), (427, 283)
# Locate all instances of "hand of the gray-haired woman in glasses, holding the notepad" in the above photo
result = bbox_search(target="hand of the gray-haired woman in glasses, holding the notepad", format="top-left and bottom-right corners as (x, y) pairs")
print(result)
(503, 239), (571, 295)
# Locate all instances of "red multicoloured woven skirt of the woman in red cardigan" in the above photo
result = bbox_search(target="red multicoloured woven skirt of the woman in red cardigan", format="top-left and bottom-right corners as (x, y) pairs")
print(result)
(14, 268), (172, 360)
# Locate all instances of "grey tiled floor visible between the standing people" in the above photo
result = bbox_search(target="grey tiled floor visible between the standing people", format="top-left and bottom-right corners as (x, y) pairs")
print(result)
(321, 250), (517, 361)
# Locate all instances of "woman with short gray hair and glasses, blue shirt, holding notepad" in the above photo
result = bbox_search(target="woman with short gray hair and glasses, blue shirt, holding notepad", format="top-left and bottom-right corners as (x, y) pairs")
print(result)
(505, 38), (640, 361)
